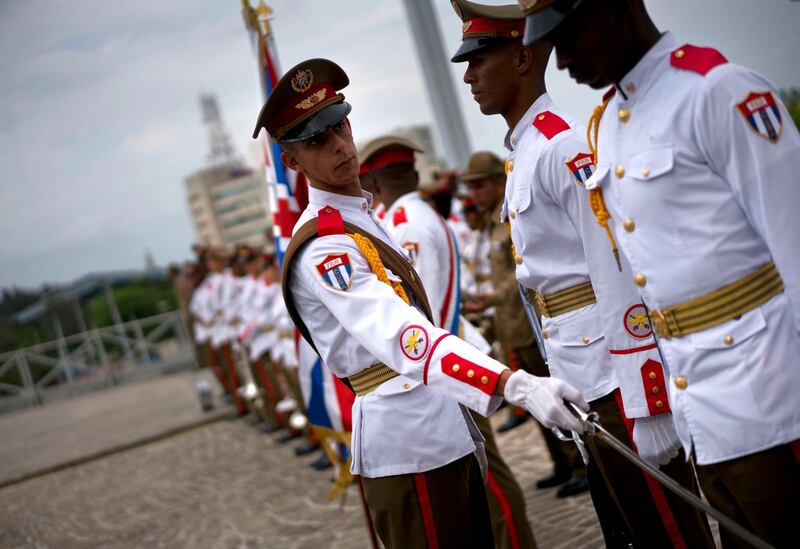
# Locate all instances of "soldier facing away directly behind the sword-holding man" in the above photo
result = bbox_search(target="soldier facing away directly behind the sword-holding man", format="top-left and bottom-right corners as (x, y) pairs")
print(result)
(358, 136), (536, 549)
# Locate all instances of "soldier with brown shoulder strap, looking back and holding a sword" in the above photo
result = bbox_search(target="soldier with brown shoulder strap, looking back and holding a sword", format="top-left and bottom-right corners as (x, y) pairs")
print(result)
(255, 59), (586, 548)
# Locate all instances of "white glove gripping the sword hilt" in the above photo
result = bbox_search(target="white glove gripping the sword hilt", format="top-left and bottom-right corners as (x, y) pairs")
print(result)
(503, 370), (589, 433)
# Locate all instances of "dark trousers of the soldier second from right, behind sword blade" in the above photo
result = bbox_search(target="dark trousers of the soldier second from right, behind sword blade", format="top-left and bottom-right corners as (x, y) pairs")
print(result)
(587, 391), (715, 549)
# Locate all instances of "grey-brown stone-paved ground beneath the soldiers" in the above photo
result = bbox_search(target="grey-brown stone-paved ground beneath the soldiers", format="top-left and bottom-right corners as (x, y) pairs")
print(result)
(0, 374), (692, 549)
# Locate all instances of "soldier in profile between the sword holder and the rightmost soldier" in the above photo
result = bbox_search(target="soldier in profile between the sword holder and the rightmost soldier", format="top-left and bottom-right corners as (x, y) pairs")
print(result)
(453, 0), (713, 547)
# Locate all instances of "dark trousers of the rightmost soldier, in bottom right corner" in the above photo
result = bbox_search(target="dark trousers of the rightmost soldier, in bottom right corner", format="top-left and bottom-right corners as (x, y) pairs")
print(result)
(697, 441), (800, 549)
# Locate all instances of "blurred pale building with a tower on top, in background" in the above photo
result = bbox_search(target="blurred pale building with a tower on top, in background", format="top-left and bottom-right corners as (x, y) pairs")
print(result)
(184, 94), (272, 246)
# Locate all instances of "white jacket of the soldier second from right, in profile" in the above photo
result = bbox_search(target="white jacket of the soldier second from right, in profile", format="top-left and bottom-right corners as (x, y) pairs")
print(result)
(504, 94), (669, 419)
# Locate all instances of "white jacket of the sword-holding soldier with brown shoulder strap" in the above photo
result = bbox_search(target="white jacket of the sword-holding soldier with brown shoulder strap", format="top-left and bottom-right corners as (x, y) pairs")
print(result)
(288, 187), (505, 478)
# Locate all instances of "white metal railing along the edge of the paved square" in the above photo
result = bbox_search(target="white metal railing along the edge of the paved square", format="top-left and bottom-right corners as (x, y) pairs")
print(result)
(0, 311), (197, 412)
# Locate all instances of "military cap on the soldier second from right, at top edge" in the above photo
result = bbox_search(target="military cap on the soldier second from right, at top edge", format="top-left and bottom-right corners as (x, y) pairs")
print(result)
(450, 0), (525, 63)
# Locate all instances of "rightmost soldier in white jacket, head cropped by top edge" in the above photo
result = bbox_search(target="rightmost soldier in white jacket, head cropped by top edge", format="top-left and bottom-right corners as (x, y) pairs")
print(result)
(526, 0), (800, 547)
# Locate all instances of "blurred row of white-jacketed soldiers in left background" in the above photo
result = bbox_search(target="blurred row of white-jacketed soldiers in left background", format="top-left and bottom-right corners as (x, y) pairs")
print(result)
(178, 245), (332, 470)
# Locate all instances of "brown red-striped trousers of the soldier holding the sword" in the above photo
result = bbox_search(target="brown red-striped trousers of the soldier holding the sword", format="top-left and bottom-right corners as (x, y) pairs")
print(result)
(361, 454), (494, 549)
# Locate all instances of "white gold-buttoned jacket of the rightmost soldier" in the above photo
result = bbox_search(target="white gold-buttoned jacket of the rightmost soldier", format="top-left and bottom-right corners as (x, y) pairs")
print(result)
(587, 33), (800, 464)
